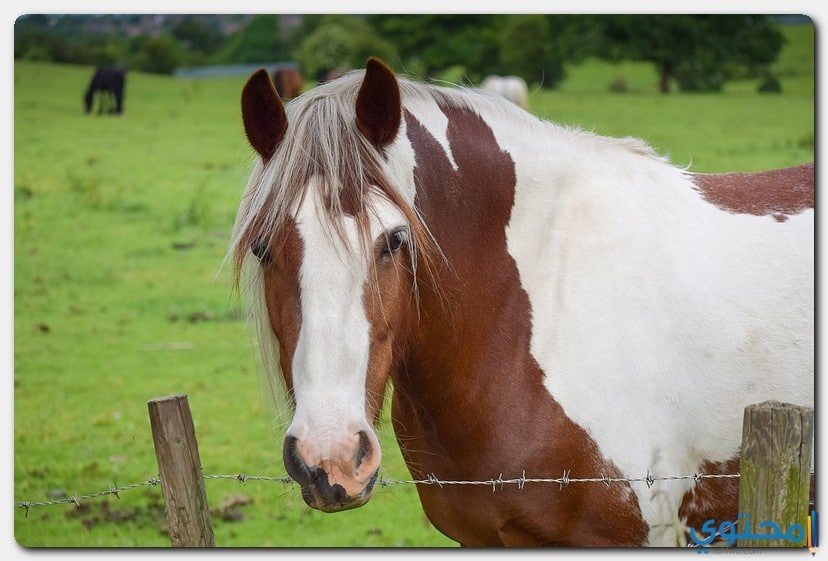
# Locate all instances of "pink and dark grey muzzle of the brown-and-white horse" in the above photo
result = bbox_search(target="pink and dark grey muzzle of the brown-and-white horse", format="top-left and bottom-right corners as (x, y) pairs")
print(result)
(283, 431), (380, 512)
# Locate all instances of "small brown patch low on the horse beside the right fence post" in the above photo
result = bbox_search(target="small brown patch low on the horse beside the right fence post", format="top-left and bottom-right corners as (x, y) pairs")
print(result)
(678, 456), (739, 534)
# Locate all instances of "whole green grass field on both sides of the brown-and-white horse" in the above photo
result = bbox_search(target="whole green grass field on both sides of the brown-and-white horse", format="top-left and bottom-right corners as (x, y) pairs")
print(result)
(14, 26), (814, 546)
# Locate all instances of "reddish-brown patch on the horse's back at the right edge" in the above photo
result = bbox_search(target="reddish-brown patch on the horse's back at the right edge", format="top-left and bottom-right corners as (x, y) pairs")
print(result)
(693, 163), (814, 222)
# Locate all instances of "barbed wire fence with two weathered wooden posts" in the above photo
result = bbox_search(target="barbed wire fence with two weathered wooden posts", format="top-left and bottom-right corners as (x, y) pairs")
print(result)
(14, 394), (814, 547)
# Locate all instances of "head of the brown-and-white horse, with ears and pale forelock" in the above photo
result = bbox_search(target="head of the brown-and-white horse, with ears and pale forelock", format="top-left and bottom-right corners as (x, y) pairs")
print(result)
(234, 59), (425, 512)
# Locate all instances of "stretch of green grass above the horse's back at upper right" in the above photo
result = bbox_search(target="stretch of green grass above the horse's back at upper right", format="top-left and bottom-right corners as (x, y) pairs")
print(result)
(530, 25), (814, 172)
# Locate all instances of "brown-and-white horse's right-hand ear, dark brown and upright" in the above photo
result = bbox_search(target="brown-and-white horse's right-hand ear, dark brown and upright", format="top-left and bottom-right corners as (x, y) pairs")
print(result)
(356, 57), (402, 146)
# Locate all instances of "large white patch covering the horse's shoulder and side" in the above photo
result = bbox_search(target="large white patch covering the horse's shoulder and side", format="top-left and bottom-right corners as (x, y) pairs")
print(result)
(466, 105), (814, 545)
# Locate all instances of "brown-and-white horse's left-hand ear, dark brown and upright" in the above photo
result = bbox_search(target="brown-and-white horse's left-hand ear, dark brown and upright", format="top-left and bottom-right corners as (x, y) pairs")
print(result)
(242, 68), (287, 160)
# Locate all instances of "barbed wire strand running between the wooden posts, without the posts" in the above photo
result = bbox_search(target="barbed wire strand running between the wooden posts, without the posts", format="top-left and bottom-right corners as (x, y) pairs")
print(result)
(14, 470), (741, 516)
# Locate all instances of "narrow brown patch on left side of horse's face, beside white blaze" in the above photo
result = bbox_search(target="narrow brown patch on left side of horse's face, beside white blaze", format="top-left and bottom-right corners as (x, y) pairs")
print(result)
(262, 219), (303, 397)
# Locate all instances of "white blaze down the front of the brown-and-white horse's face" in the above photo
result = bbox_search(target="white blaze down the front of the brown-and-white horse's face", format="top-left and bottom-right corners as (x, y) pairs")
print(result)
(288, 178), (406, 446)
